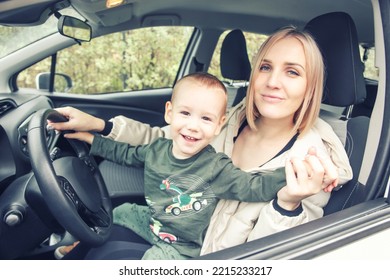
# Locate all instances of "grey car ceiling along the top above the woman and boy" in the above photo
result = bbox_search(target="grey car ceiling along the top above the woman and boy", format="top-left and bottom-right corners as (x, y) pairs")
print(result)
(0, 0), (374, 44)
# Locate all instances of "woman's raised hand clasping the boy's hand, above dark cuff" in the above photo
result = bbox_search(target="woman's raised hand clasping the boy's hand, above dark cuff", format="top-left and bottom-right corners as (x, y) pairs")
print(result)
(278, 148), (338, 211)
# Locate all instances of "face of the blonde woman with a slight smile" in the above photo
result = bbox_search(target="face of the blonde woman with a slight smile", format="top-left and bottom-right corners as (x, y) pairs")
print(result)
(253, 37), (307, 122)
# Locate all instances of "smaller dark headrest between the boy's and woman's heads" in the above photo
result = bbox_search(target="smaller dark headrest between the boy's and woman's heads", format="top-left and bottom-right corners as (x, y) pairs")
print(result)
(220, 29), (251, 81)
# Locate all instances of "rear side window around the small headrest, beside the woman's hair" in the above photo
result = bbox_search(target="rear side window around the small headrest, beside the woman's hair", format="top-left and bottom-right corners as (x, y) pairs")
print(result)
(208, 30), (267, 83)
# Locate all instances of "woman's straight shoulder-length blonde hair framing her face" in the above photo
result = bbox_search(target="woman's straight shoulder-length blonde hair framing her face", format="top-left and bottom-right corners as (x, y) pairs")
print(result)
(246, 26), (325, 134)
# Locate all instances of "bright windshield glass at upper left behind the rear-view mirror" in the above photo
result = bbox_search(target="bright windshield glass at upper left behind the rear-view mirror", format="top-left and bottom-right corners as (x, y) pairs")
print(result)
(0, 8), (80, 58)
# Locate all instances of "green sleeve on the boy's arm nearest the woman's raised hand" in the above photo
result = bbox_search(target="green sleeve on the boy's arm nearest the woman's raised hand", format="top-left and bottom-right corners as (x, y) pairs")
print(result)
(213, 157), (286, 202)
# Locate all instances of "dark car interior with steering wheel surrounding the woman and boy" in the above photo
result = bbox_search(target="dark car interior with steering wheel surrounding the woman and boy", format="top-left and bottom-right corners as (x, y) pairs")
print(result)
(0, 0), (390, 260)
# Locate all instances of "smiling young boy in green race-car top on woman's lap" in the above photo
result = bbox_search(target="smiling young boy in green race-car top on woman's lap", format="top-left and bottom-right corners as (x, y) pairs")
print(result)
(59, 73), (286, 259)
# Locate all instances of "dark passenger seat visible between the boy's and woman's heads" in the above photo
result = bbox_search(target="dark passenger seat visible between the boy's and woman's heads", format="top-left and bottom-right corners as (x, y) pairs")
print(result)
(220, 29), (251, 107)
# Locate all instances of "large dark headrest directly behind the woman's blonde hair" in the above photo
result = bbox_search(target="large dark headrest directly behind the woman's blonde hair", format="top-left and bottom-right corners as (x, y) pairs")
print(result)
(305, 12), (366, 107)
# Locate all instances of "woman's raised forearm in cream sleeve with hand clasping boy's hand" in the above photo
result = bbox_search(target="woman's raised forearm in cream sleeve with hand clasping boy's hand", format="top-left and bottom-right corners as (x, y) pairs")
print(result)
(247, 152), (338, 241)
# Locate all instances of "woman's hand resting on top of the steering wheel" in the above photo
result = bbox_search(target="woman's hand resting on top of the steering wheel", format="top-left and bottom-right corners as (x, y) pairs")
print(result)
(48, 107), (105, 135)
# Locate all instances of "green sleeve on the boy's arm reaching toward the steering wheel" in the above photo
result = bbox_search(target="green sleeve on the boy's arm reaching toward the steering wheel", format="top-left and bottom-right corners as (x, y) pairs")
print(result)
(90, 135), (147, 167)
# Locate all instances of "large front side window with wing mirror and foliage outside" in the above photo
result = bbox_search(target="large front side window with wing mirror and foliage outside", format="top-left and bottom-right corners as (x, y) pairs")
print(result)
(17, 27), (194, 94)
